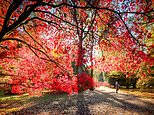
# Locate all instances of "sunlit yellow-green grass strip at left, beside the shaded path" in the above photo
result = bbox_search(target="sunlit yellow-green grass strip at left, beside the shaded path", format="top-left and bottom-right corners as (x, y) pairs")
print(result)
(0, 94), (68, 114)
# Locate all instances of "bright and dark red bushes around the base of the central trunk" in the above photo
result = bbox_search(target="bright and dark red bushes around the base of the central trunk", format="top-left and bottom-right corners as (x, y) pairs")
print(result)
(48, 72), (94, 94)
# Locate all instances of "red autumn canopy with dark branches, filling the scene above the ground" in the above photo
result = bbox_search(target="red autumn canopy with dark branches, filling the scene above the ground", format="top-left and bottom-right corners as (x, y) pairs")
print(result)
(0, 0), (154, 93)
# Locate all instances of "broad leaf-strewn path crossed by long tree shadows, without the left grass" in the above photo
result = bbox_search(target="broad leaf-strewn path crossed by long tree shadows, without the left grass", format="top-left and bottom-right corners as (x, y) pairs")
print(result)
(4, 87), (154, 115)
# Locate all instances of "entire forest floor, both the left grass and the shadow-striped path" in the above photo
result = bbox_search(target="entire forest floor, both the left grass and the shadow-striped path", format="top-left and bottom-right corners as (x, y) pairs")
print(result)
(0, 86), (154, 115)
